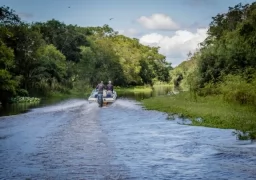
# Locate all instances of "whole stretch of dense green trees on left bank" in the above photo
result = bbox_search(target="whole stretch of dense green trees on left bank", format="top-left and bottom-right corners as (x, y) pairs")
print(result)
(0, 6), (172, 104)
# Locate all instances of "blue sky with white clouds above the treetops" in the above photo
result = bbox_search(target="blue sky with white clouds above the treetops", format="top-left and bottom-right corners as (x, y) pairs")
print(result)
(0, 0), (254, 66)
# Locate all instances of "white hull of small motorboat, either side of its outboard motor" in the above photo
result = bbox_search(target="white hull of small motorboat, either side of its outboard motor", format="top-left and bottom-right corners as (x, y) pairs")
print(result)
(88, 89), (117, 104)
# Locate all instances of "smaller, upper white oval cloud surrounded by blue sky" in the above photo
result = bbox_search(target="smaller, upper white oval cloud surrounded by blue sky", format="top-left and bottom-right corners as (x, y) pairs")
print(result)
(137, 14), (179, 30)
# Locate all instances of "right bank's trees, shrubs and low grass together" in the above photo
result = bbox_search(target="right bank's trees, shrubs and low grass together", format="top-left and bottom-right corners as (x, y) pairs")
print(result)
(166, 2), (256, 139)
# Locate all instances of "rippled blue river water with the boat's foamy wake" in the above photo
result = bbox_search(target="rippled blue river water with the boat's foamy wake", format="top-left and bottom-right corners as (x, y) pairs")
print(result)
(0, 99), (256, 180)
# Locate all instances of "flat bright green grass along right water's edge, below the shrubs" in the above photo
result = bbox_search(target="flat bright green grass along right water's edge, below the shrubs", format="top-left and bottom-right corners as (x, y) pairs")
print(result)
(142, 92), (256, 139)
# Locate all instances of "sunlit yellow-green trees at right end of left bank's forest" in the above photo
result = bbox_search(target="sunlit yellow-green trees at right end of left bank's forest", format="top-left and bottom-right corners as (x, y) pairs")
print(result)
(110, 35), (171, 85)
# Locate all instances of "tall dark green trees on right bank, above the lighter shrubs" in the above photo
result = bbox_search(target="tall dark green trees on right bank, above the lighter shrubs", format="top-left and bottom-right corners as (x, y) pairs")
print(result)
(198, 3), (256, 86)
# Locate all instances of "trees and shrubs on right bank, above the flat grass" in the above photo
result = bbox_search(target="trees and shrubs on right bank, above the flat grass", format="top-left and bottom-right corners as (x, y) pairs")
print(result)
(171, 2), (256, 106)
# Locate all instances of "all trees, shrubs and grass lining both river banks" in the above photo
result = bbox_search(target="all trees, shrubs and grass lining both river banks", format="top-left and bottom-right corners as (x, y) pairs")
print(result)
(0, 2), (256, 139)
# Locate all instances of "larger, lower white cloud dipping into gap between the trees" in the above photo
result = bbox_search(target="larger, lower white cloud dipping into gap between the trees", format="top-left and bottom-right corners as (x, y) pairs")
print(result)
(140, 28), (207, 66)
